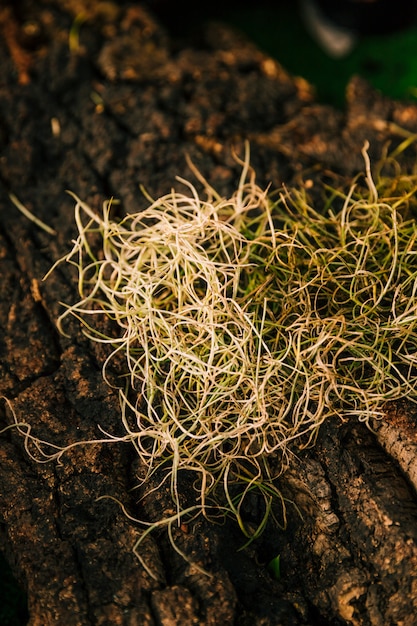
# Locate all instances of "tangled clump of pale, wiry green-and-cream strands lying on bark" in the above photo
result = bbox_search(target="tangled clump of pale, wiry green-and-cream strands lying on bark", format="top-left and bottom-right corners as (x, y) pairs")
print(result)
(47, 148), (417, 556)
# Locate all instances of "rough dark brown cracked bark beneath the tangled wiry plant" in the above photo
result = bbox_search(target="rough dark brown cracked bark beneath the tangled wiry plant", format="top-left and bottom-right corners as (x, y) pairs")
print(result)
(0, 0), (417, 626)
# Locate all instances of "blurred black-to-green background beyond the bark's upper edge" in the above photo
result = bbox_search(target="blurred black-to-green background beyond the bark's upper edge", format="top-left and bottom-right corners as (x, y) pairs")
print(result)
(151, 0), (417, 108)
